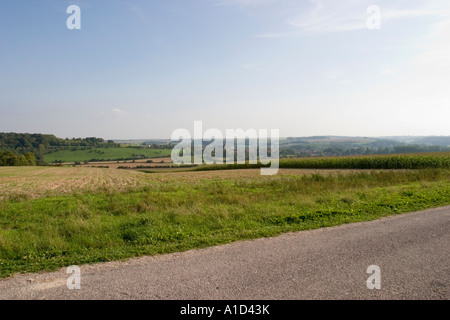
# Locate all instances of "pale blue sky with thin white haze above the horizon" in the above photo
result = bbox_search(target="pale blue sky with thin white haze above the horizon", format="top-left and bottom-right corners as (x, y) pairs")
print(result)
(0, 0), (450, 139)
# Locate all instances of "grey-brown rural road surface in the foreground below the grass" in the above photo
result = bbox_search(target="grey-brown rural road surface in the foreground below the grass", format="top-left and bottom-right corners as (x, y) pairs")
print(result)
(0, 206), (450, 300)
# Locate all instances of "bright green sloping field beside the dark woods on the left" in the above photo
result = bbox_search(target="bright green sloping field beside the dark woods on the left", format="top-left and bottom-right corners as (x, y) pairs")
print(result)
(44, 148), (171, 163)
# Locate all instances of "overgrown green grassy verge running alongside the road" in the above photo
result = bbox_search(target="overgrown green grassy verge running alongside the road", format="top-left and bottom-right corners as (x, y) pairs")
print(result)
(0, 169), (450, 277)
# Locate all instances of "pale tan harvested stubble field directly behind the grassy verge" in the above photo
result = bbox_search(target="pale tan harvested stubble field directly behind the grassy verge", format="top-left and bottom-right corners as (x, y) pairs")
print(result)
(0, 166), (361, 200)
